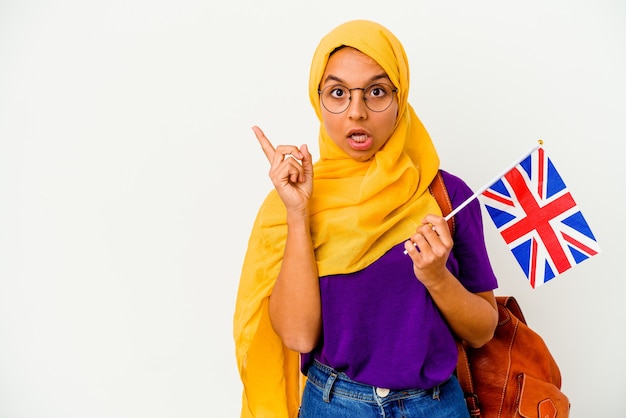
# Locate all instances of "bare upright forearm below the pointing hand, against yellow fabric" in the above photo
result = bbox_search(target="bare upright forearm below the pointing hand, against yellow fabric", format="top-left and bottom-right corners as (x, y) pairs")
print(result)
(269, 213), (322, 353)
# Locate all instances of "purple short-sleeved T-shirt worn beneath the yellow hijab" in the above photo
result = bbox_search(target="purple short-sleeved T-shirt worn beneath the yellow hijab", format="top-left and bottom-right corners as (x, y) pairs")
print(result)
(302, 171), (497, 390)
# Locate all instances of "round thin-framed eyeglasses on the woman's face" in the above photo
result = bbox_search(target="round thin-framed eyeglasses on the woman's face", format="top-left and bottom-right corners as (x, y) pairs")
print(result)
(317, 83), (398, 113)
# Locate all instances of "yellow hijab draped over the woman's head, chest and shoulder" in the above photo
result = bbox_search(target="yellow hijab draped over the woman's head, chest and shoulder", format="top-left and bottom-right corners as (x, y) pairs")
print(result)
(234, 20), (441, 418)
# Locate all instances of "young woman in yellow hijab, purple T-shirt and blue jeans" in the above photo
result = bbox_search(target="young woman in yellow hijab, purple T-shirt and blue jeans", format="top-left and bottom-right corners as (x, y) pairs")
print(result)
(235, 21), (497, 418)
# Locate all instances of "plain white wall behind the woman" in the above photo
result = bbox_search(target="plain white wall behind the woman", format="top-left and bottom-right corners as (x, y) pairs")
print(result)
(0, 0), (626, 418)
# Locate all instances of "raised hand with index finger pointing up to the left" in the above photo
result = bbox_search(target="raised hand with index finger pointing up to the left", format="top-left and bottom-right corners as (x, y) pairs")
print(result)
(252, 126), (313, 213)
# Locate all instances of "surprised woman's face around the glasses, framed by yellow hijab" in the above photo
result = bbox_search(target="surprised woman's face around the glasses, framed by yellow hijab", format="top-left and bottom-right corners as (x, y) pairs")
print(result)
(320, 47), (398, 161)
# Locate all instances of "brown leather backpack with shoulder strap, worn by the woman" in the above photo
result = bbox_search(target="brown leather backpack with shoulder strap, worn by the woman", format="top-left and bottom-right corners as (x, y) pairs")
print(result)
(430, 173), (570, 418)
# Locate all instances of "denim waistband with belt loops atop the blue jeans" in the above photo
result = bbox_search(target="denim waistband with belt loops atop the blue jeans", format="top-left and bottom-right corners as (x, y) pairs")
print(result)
(307, 360), (448, 404)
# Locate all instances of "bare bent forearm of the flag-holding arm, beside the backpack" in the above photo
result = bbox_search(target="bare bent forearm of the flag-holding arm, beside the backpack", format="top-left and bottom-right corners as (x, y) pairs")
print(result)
(428, 270), (498, 347)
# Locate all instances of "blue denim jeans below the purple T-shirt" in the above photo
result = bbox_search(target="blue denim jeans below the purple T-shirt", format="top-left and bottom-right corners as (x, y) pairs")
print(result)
(298, 361), (469, 418)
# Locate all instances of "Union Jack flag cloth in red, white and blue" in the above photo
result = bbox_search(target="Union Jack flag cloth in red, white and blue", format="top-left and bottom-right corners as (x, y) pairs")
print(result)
(482, 147), (600, 288)
